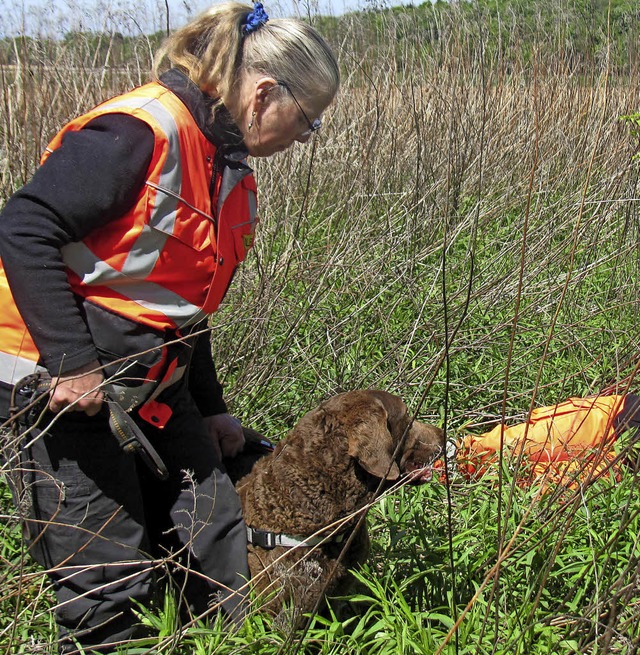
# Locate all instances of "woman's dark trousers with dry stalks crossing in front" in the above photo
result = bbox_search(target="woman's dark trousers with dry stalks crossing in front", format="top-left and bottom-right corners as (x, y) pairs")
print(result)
(6, 389), (249, 653)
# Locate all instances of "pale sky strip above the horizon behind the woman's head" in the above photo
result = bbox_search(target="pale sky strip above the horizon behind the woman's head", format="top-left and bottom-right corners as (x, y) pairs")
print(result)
(0, 0), (400, 36)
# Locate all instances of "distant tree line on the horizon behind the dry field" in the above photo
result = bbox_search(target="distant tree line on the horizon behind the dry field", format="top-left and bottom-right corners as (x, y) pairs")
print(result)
(0, 0), (640, 75)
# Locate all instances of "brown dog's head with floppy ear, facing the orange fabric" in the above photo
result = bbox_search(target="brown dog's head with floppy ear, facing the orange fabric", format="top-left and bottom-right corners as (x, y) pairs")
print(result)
(323, 390), (444, 483)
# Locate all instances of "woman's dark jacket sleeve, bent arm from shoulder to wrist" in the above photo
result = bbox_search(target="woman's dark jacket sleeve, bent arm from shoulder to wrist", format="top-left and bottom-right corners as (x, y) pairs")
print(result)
(0, 114), (154, 375)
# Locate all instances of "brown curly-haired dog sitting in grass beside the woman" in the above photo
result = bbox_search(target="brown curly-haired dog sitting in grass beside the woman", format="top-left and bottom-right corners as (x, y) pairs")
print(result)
(237, 390), (444, 627)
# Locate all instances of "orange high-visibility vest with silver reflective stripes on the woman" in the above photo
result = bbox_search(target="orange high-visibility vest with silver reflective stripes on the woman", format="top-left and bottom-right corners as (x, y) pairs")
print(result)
(0, 82), (257, 384)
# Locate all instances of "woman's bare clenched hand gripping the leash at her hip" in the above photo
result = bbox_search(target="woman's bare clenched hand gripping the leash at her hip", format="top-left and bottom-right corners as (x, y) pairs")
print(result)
(49, 361), (104, 416)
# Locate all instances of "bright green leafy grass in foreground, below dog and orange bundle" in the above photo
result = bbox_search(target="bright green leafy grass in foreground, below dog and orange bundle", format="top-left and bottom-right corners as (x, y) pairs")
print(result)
(2, 472), (640, 655)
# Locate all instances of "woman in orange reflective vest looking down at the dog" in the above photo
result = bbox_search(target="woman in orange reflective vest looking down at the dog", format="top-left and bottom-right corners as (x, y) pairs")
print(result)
(0, 3), (339, 652)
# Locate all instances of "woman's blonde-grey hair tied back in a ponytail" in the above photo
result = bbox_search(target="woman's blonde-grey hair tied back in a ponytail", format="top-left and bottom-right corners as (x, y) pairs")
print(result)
(153, 2), (340, 109)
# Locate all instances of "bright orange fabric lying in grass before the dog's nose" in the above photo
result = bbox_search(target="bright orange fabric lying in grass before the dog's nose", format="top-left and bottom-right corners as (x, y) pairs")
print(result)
(456, 395), (624, 487)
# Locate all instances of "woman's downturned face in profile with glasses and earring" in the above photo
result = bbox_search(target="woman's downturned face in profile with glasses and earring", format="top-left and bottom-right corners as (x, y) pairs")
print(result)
(239, 78), (326, 157)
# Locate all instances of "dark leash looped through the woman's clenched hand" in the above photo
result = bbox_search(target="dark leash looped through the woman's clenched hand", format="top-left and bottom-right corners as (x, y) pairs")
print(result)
(9, 373), (169, 480)
